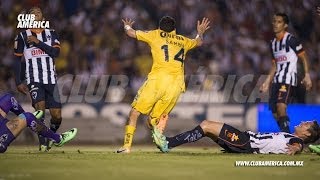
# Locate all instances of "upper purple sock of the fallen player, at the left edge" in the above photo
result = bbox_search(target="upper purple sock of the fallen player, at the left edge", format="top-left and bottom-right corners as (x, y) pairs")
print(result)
(0, 93), (24, 115)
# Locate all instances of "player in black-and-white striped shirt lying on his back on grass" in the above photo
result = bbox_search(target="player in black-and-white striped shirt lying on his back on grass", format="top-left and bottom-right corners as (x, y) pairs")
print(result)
(152, 120), (319, 155)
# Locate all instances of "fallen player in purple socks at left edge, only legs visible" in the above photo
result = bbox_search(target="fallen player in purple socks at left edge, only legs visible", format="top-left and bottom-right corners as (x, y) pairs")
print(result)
(0, 94), (77, 153)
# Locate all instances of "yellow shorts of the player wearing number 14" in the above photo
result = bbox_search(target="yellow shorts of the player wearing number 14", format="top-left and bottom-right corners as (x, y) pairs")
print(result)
(131, 78), (182, 119)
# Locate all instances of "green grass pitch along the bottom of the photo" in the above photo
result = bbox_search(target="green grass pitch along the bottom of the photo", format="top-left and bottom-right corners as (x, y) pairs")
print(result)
(0, 145), (320, 180)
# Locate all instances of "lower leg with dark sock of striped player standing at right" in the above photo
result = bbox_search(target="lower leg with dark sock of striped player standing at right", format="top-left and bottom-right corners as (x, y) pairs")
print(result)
(277, 103), (290, 133)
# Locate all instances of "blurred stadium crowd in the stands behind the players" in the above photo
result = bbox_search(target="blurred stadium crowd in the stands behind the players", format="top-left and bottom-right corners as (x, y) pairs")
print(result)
(0, 0), (320, 103)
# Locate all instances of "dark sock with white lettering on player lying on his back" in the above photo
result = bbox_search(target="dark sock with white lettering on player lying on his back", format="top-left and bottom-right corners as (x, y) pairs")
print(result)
(167, 125), (204, 148)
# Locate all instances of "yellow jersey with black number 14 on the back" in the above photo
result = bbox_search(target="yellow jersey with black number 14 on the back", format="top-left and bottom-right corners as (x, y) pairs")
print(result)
(136, 29), (197, 77)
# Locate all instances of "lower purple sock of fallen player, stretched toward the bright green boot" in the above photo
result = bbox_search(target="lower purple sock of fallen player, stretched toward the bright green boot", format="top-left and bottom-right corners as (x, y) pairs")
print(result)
(19, 112), (60, 143)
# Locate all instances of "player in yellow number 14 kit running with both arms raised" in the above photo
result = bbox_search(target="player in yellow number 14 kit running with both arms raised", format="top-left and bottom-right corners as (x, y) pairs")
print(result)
(117, 16), (210, 153)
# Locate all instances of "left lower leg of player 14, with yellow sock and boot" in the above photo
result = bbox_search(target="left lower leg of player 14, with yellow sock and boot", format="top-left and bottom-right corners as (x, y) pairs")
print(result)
(117, 108), (141, 153)
